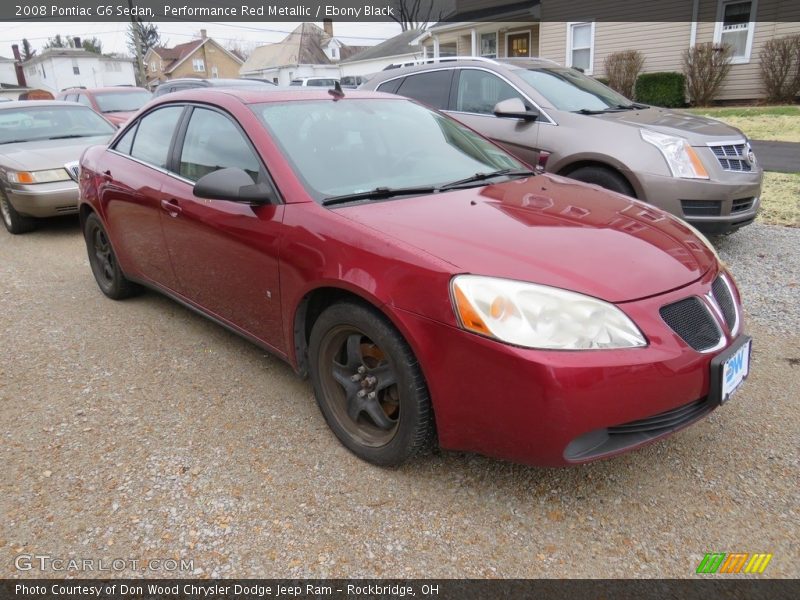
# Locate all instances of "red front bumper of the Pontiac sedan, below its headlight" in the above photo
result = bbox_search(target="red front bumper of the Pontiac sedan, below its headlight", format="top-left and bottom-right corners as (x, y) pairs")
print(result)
(396, 272), (741, 466)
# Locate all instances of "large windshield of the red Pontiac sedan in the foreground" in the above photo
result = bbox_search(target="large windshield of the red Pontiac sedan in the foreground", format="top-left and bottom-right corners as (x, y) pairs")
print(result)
(252, 99), (524, 201)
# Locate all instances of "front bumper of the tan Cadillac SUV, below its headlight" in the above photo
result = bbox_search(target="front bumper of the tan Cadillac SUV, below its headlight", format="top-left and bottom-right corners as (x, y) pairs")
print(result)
(629, 170), (762, 234)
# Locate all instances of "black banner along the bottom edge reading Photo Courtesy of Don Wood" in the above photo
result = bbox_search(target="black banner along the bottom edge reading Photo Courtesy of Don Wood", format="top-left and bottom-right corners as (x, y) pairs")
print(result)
(0, 576), (800, 600)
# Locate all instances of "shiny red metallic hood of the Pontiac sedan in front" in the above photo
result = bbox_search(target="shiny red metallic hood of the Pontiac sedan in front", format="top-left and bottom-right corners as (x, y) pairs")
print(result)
(335, 175), (716, 302)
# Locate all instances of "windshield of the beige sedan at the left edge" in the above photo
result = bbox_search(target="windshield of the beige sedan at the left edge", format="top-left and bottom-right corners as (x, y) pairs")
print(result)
(0, 106), (116, 144)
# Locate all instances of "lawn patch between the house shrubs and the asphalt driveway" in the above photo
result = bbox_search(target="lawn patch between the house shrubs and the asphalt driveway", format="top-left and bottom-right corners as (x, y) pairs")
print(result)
(689, 106), (800, 142)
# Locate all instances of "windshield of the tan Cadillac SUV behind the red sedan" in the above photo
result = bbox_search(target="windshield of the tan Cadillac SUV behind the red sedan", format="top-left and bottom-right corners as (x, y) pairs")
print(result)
(516, 67), (631, 112)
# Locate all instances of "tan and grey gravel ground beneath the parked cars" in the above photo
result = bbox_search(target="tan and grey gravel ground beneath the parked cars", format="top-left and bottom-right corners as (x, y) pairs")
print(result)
(0, 220), (800, 578)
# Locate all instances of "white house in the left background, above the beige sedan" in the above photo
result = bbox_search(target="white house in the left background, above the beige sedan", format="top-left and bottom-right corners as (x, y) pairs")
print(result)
(23, 48), (136, 95)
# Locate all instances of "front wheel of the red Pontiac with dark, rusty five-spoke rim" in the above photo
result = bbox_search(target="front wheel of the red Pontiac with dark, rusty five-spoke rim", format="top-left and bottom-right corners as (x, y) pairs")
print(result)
(309, 302), (435, 466)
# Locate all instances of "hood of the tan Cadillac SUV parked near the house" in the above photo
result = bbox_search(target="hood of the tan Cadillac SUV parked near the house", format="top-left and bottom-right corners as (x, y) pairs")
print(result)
(596, 108), (745, 146)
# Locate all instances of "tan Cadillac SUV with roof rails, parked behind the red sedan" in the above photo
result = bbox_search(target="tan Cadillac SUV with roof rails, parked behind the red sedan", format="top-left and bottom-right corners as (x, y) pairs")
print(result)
(361, 58), (762, 233)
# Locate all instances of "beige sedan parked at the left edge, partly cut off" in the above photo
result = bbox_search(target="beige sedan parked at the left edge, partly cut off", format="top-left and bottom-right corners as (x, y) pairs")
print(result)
(0, 100), (114, 234)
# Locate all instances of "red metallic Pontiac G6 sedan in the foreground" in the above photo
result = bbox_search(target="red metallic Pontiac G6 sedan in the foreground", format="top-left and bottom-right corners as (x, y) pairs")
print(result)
(80, 89), (750, 465)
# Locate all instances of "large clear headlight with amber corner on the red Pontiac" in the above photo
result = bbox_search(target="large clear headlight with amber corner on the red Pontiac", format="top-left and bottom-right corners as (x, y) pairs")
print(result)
(450, 275), (647, 350)
